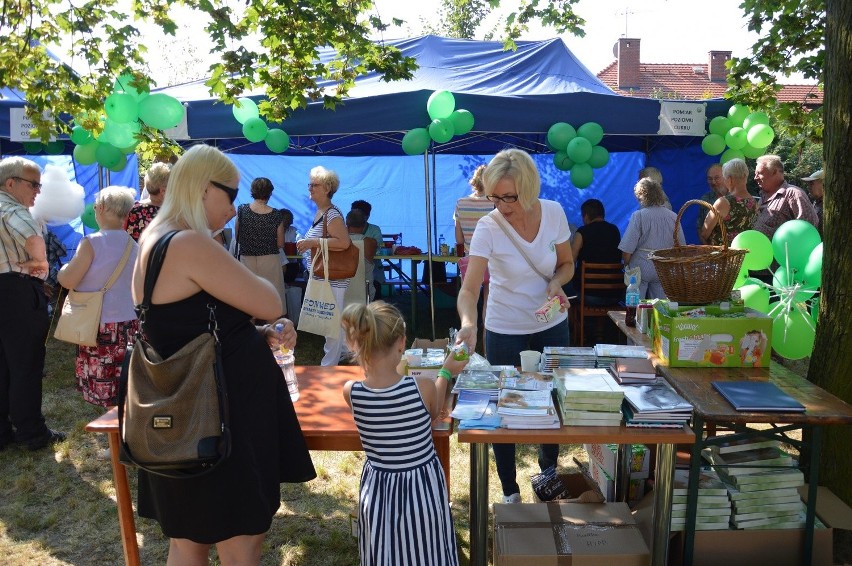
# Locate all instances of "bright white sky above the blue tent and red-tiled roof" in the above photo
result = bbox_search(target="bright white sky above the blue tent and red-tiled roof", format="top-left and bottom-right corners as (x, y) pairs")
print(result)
(375, 0), (757, 78)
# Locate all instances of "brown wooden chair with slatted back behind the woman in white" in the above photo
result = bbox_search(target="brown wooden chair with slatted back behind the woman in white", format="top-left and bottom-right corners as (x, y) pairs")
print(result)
(571, 261), (627, 346)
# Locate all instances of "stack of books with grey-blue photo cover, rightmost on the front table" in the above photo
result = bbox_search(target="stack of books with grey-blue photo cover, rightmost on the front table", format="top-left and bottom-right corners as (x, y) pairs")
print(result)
(622, 379), (692, 428)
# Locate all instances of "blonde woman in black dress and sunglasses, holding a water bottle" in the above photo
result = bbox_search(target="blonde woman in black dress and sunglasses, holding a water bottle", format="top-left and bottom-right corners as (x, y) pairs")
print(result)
(133, 145), (316, 566)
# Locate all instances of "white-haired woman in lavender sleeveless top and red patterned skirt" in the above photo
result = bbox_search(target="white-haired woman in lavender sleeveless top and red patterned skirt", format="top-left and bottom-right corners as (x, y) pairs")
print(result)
(57, 186), (138, 407)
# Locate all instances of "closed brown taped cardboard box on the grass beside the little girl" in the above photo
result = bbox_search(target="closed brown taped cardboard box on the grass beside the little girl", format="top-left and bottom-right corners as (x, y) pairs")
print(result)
(494, 502), (651, 566)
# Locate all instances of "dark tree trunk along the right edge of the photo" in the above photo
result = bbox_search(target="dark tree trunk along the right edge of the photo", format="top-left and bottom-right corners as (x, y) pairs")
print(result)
(808, 0), (852, 505)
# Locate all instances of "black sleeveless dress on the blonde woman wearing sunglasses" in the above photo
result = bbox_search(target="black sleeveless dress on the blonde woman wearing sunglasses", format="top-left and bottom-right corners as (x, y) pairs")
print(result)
(138, 291), (316, 544)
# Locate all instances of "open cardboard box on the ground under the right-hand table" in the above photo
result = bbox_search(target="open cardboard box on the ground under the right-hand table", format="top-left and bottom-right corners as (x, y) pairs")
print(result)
(669, 485), (852, 566)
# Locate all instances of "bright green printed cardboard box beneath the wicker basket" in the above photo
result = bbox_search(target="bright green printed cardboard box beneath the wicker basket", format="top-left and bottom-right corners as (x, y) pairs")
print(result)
(650, 301), (772, 367)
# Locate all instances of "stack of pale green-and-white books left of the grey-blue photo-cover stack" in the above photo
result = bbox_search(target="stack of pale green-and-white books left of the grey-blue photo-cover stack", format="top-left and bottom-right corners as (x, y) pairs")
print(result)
(553, 368), (624, 426)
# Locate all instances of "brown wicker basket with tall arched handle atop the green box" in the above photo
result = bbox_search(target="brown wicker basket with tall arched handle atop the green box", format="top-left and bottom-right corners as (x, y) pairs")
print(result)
(648, 200), (748, 305)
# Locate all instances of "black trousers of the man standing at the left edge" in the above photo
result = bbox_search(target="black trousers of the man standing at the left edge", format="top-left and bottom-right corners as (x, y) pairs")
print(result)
(0, 273), (50, 441)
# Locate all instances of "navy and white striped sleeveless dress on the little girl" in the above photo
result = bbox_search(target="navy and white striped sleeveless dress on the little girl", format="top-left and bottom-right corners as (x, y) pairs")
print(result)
(351, 376), (458, 566)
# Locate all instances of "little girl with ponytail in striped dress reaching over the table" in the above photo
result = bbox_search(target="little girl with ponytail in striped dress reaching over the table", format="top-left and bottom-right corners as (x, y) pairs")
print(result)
(342, 301), (467, 566)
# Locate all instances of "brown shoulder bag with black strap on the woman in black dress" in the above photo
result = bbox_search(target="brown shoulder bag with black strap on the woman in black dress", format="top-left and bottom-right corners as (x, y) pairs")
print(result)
(118, 231), (231, 479)
